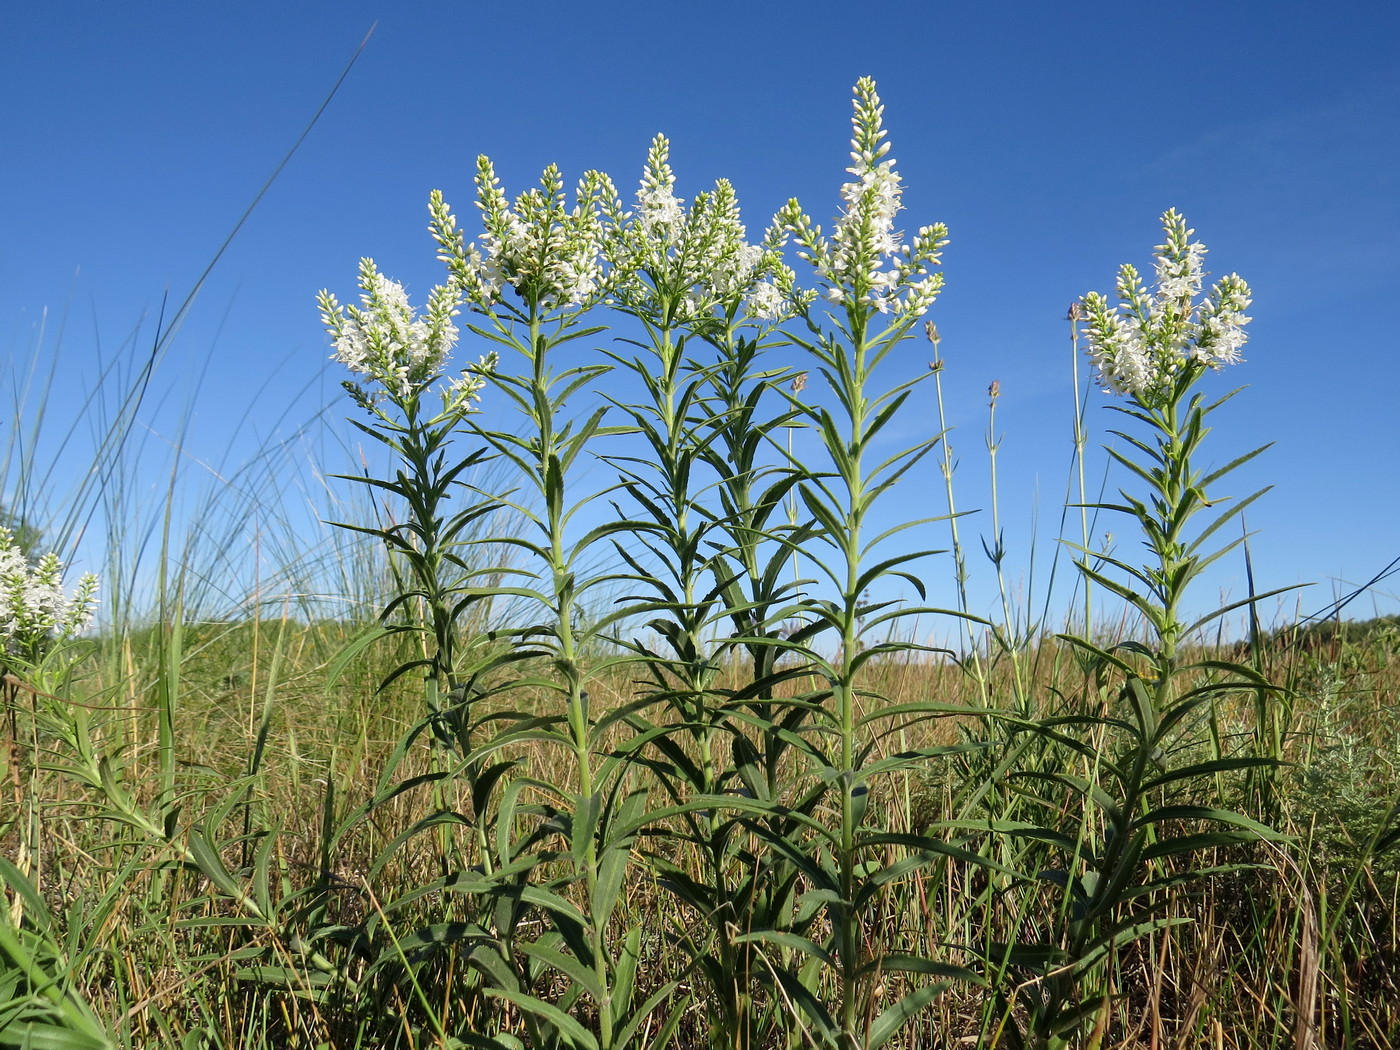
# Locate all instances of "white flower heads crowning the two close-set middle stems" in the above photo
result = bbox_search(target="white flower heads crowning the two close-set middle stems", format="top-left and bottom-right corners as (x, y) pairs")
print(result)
(608, 134), (794, 323)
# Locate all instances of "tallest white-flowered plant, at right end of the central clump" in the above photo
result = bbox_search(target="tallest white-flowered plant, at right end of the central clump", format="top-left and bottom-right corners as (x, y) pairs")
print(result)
(756, 78), (970, 1047)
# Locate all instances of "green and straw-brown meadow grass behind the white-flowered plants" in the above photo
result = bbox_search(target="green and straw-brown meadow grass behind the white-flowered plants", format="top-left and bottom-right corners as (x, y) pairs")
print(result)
(3, 620), (1400, 1047)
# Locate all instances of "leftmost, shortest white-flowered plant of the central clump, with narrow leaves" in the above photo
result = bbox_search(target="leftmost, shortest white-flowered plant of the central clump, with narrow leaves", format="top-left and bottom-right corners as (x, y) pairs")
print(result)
(318, 259), (519, 991)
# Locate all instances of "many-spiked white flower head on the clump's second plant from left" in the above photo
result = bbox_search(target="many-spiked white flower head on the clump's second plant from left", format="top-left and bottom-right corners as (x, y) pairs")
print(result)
(430, 157), (617, 309)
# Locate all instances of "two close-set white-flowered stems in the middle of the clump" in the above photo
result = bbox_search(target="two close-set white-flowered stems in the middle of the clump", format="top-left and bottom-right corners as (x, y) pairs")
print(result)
(596, 136), (819, 1050)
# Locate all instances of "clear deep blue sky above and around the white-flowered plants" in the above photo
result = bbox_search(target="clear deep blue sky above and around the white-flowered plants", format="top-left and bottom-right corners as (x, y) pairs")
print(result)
(0, 0), (1400, 632)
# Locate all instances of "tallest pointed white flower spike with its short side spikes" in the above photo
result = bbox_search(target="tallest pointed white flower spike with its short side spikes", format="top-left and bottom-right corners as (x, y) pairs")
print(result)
(780, 77), (948, 316)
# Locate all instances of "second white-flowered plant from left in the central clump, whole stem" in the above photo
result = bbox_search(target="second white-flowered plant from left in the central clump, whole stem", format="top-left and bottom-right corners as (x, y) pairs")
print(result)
(430, 157), (683, 1049)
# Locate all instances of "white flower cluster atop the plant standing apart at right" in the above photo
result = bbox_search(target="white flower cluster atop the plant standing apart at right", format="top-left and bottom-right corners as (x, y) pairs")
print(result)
(1081, 209), (1250, 406)
